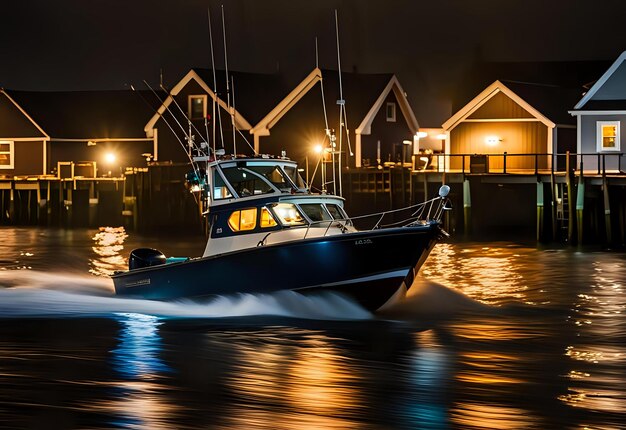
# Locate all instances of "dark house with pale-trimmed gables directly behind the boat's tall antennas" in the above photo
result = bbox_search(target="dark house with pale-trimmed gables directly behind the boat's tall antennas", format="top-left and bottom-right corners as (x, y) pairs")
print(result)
(250, 68), (419, 168)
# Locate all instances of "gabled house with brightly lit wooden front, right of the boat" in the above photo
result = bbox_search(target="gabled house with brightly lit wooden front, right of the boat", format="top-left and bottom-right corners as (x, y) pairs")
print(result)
(442, 80), (578, 172)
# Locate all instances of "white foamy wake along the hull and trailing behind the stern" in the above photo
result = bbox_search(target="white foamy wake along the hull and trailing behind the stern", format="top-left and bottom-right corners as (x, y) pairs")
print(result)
(0, 270), (372, 320)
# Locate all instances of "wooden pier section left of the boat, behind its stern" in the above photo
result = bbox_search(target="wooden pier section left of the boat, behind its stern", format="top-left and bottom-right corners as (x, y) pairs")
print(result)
(0, 165), (202, 231)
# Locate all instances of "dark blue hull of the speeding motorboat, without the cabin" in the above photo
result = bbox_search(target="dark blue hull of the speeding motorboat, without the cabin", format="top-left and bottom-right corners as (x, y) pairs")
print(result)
(112, 223), (445, 310)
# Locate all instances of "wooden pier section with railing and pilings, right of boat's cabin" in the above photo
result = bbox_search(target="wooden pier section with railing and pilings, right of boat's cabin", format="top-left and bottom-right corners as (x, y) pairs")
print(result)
(344, 153), (626, 246)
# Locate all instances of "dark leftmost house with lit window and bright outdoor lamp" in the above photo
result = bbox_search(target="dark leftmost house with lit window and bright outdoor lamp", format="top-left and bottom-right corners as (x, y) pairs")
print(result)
(0, 89), (154, 177)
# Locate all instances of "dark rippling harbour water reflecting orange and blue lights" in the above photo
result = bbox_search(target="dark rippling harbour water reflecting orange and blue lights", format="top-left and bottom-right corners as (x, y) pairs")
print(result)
(0, 228), (626, 429)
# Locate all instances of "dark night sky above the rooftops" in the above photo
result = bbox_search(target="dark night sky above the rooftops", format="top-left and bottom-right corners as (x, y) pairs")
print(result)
(0, 0), (626, 127)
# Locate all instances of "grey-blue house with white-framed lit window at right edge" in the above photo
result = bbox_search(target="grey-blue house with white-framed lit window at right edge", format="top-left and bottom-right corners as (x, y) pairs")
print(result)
(569, 51), (626, 173)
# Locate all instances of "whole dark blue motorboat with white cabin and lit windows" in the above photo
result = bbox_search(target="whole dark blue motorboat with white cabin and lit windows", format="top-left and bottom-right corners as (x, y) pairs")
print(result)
(112, 155), (450, 311)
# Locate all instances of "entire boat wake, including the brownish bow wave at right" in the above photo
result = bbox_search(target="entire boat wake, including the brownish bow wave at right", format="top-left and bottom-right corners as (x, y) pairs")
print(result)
(0, 270), (491, 321)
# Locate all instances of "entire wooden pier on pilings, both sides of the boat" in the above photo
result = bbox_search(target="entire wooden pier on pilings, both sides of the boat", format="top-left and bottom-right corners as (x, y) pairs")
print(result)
(0, 154), (626, 246)
